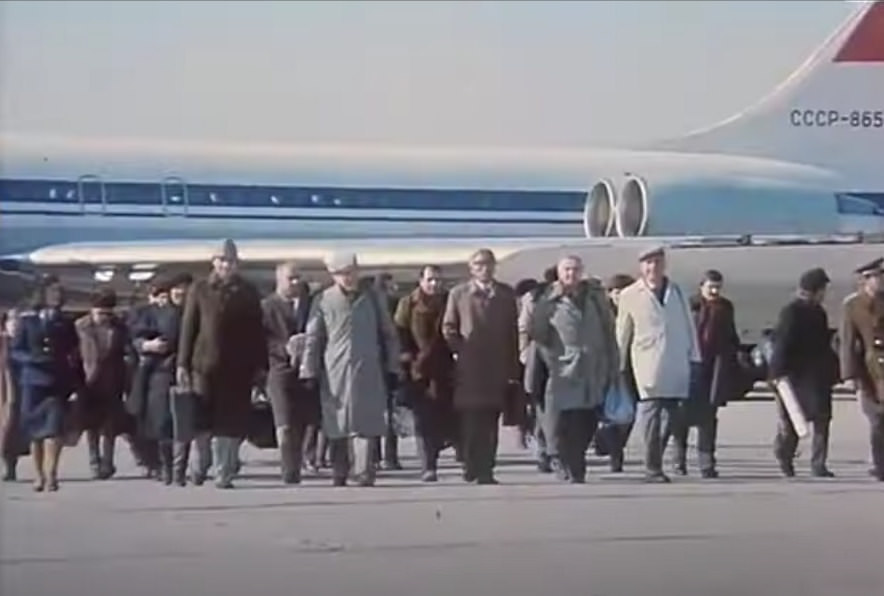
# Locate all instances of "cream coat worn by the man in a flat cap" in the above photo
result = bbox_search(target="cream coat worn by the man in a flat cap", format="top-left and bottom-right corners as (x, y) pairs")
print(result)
(617, 280), (700, 399)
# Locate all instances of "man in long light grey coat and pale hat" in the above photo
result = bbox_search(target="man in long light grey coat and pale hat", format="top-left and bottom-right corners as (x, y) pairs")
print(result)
(300, 254), (399, 486)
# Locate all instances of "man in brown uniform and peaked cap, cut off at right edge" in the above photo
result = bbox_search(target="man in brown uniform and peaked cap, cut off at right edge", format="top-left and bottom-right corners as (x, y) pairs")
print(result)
(840, 259), (884, 482)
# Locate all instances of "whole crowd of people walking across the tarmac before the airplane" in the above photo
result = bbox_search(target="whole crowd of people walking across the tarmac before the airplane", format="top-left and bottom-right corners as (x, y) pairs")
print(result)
(0, 240), (884, 492)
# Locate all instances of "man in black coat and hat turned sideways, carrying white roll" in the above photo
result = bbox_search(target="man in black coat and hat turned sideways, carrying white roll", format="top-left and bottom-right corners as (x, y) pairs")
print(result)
(769, 268), (839, 478)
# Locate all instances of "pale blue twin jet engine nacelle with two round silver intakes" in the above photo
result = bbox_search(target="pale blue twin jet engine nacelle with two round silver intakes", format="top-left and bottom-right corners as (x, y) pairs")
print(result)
(583, 175), (843, 238)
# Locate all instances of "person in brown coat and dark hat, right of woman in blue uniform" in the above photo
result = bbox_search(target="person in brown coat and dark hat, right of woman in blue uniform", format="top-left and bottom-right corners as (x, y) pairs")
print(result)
(74, 288), (129, 480)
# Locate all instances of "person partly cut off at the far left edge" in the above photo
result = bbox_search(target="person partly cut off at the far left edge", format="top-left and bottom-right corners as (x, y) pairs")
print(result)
(0, 309), (29, 482)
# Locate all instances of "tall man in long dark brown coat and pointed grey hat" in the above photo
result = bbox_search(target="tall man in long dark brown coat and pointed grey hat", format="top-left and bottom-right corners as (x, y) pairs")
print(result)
(176, 239), (267, 488)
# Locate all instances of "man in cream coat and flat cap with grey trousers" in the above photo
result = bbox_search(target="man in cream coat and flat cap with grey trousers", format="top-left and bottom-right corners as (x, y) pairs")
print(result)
(617, 247), (701, 483)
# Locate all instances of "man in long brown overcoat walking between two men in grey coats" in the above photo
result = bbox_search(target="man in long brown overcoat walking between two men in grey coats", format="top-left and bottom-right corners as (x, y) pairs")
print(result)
(442, 249), (520, 484)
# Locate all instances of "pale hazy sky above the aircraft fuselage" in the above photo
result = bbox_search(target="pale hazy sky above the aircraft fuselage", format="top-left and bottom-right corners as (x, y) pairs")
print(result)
(0, 0), (854, 145)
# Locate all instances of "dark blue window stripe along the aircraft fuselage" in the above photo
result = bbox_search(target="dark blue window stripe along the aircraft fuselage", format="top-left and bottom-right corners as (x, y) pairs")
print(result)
(0, 180), (585, 211)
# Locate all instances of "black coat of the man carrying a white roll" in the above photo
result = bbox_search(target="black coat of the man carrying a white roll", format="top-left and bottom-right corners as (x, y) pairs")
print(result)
(770, 298), (839, 420)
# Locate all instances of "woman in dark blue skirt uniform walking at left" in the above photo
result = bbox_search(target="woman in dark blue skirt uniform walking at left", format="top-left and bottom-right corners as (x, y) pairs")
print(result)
(10, 277), (82, 492)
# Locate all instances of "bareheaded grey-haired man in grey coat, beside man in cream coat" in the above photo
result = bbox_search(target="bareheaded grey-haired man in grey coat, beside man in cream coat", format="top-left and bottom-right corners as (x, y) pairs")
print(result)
(530, 256), (619, 484)
